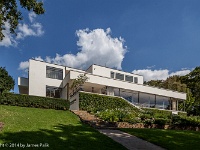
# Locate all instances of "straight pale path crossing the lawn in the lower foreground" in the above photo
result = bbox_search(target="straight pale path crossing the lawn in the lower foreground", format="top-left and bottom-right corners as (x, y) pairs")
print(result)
(98, 129), (164, 150)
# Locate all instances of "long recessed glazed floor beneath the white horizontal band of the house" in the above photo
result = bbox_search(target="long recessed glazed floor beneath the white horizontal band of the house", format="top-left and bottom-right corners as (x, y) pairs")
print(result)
(66, 84), (185, 111)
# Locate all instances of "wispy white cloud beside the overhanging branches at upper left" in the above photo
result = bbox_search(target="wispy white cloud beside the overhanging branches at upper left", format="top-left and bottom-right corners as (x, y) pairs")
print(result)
(0, 12), (44, 47)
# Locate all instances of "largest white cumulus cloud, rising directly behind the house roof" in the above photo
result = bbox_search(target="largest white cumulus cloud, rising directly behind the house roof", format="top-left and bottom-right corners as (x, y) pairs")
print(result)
(19, 28), (126, 69)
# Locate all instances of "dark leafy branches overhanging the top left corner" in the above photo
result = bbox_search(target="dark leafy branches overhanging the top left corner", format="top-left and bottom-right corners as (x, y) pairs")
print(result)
(0, 0), (45, 41)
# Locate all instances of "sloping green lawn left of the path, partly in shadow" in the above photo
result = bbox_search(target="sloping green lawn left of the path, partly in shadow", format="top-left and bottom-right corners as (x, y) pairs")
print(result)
(0, 105), (125, 150)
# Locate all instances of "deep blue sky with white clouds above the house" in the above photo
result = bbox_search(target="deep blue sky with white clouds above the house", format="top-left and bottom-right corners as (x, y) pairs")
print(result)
(0, 0), (200, 92)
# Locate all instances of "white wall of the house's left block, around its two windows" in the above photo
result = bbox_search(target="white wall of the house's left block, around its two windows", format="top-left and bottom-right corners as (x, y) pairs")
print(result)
(29, 59), (65, 96)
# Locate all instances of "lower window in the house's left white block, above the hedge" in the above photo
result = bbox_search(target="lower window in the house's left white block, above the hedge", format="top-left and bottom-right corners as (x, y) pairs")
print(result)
(46, 86), (61, 98)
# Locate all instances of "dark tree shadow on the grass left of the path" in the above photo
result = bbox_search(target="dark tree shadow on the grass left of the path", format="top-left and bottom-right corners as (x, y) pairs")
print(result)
(0, 124), (125, 150)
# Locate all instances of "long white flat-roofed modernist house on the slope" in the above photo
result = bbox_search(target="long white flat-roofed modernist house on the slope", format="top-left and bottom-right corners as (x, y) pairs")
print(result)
(18, 59), (186, 111)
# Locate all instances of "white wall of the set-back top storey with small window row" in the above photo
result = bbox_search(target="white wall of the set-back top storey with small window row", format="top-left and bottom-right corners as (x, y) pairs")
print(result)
(90, 65), (143, 84)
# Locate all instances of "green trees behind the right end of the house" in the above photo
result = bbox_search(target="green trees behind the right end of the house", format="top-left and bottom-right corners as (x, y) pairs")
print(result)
(144, 67), (200, 115)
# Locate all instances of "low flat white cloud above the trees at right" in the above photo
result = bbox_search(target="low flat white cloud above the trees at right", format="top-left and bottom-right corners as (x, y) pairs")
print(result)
(132, 69), (191, 81)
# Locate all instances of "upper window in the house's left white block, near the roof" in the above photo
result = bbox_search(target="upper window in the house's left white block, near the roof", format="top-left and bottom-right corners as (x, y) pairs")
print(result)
(46, 66), (63, 80)
